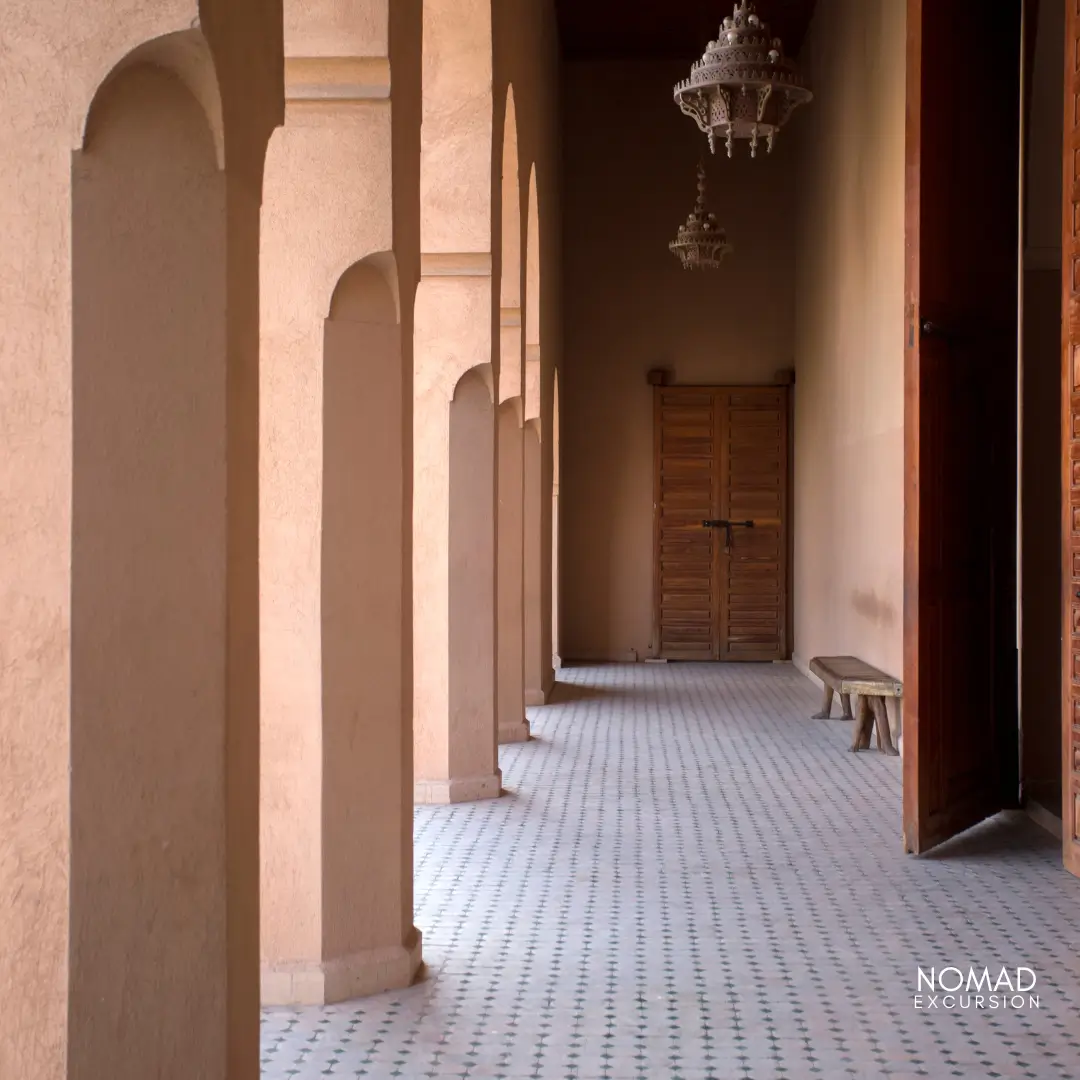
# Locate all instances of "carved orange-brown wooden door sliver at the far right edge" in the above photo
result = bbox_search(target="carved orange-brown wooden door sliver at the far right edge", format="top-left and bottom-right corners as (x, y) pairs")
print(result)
(1062, 0), (1080, 876)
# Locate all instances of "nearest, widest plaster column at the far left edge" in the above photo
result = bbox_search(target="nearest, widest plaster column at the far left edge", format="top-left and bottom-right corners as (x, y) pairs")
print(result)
(0, 8), (282, 1080)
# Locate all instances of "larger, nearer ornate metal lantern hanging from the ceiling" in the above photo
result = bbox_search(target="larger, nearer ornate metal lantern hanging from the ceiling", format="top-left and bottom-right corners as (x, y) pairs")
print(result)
(675, 0), (813, 158)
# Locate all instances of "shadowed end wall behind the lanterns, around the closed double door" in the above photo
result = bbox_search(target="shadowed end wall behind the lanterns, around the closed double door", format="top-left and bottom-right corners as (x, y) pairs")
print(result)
(561, 63), (801, 660)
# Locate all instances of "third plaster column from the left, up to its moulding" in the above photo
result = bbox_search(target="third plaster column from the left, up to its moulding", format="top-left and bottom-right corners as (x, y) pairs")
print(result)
(413, 272), (502, 804)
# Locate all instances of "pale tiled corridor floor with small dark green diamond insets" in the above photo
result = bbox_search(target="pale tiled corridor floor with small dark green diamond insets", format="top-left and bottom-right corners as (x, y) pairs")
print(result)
(262, 664), (1080, 1080)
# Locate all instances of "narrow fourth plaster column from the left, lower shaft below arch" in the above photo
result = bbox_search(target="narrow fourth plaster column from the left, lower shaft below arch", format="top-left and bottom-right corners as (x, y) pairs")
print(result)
(499, 397), (529, 743)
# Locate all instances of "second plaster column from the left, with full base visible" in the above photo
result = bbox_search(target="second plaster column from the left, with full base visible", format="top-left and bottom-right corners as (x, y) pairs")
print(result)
(261, 16), (421, 1004)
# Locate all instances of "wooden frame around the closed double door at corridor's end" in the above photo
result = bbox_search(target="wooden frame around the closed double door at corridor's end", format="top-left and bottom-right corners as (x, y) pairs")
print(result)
(649, 378), (795, 660)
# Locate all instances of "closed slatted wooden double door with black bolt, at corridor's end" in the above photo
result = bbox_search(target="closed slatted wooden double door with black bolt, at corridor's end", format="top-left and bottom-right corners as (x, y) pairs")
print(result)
(652, 386), (788, 661)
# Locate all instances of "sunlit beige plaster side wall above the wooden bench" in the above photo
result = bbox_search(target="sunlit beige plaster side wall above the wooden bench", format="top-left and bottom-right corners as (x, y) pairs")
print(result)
(792, 0), (905, 675)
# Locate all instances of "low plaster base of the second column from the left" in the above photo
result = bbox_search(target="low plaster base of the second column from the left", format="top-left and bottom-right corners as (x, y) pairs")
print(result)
(260, 927), (422, 1005)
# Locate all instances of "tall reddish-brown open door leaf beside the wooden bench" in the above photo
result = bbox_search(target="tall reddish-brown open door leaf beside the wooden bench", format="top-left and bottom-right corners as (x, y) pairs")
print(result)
(904, 0), (1019, 852)
